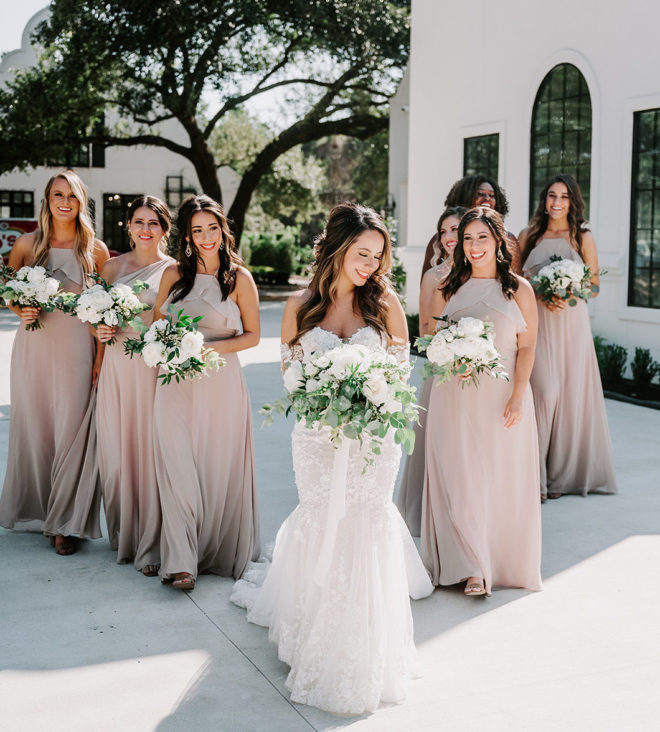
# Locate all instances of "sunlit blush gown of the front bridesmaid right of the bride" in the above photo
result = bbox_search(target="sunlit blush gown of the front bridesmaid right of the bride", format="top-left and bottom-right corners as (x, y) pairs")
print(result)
(421, 278), (541, 592)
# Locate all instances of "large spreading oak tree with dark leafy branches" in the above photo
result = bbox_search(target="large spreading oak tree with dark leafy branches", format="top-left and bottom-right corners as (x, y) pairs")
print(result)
(0, 0), (409, 238)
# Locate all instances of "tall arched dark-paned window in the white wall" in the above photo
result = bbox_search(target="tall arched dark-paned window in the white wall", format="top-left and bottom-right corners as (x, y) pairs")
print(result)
(529, 64), (591, 218)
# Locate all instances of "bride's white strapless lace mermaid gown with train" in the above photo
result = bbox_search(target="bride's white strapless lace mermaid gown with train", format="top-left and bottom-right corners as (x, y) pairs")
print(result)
(231, 327), (433, 714)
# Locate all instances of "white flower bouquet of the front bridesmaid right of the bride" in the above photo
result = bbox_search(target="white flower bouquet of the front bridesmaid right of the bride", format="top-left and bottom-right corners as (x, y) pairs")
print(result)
(415, 318), (509, 386)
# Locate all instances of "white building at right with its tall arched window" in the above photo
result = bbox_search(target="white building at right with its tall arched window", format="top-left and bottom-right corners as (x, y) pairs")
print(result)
(390, 0), (660, 359)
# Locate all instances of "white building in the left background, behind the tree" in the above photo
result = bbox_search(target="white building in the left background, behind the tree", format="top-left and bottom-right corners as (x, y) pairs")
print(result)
(0, 8), (239, 251)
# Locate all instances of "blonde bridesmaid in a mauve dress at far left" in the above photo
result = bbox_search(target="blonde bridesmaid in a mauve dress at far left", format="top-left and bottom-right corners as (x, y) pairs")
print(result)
(0, 171), (108, 555)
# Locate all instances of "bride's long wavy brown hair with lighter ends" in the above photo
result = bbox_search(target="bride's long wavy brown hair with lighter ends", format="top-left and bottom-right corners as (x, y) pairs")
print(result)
(291, 202), (392, 344)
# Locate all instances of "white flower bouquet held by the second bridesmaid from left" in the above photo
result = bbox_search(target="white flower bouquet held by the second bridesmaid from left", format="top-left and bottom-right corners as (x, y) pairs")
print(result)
(73, 275), (149, 346)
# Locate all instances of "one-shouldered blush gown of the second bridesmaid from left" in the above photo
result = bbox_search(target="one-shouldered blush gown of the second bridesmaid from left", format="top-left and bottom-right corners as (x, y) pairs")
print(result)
(96, 257), (174, 570)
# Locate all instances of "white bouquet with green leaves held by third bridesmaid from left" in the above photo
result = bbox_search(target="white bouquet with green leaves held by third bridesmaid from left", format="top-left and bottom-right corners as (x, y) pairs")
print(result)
(124, 306), (227, 384)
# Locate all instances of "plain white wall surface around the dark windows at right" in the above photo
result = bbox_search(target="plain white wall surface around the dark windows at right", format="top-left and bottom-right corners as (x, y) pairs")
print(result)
(404, 0), (660, 358)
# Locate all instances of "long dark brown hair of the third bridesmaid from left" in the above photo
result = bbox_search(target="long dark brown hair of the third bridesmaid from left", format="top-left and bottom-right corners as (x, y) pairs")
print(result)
(170, 194), (243, 302)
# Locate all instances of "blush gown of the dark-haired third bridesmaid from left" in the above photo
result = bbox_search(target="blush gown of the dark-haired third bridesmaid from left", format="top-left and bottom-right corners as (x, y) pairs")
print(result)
(154, 274), (259, 580)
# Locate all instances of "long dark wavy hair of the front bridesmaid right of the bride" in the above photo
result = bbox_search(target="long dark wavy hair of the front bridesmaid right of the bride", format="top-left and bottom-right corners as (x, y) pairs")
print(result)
(441, 206), (518, 300)
